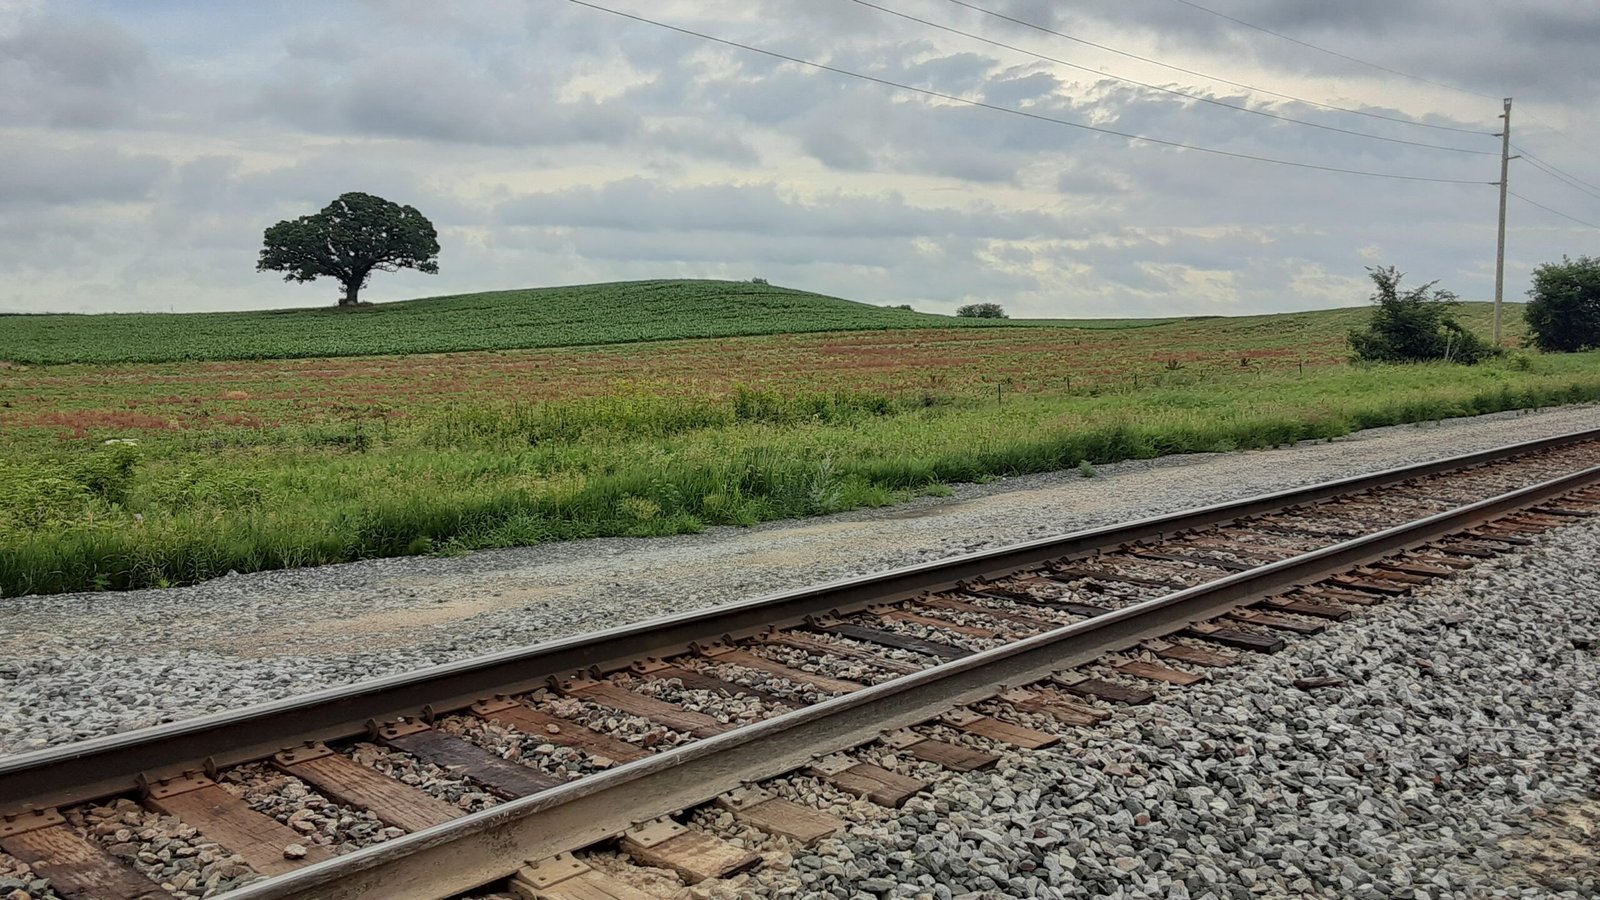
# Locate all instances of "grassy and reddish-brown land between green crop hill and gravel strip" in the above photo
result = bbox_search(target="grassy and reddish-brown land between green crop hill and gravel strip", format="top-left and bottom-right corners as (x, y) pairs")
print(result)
(0, 277), (1600, 596)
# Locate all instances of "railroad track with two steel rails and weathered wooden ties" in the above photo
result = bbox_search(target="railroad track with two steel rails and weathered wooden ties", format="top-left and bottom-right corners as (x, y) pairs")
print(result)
(0, 431), (1600, 900)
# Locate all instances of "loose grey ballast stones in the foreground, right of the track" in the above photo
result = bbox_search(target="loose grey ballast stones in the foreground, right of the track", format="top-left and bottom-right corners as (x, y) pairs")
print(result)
(744, 509), (1600, 900)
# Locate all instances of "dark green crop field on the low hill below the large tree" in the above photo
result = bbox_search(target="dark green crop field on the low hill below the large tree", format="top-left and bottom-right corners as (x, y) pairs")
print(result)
(0, 280), (1177, 365)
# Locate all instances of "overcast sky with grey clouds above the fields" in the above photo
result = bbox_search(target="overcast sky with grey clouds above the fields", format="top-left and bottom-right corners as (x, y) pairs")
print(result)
(0, 0), (1600, 317)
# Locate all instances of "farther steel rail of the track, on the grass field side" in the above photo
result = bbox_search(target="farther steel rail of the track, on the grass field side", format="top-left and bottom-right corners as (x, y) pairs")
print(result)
(0, 419), (1600, 812)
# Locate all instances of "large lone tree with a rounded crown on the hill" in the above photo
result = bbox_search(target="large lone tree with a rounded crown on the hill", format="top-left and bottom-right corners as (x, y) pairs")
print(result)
(256, 191), (438, 306)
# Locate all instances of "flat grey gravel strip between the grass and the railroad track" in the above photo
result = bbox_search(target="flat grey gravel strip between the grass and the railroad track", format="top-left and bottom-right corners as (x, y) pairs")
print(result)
(0, 407), (1600, 753)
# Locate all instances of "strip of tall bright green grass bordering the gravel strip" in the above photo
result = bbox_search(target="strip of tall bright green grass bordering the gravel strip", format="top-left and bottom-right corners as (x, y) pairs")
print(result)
(0, 356), (1600, 596)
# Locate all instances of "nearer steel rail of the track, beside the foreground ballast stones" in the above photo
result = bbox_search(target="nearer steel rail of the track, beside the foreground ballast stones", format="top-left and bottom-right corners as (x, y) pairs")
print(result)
(227, 466), (1600, 900)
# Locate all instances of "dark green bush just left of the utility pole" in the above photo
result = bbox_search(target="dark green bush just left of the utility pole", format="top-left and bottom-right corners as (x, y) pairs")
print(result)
(1349, 266), (1494, 365)
